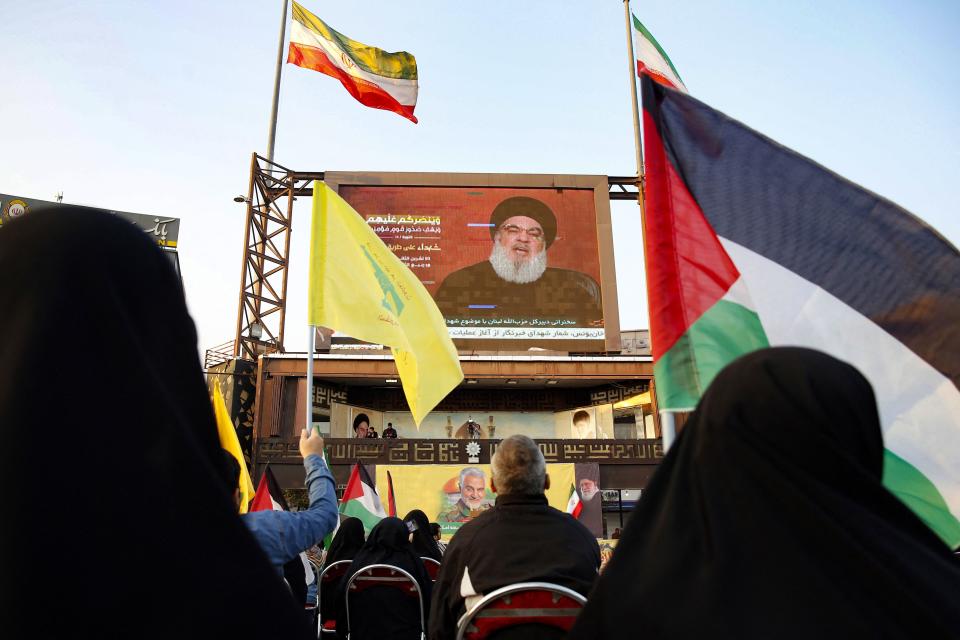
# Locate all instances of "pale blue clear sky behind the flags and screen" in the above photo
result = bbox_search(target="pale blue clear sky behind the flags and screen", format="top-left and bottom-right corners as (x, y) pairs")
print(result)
(0, 0), (960, 350)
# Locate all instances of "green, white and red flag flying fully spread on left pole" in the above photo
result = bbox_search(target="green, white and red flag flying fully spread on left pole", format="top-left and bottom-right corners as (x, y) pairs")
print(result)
(287, 2), (417, 123)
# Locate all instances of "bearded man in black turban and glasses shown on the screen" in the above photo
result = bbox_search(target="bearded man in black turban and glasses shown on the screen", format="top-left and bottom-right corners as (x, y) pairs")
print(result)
(434, 196), (603, 327)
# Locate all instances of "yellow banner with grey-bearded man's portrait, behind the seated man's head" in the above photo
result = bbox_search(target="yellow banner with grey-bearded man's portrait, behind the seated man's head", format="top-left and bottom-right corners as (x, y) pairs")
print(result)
(376, 464), (574, 540)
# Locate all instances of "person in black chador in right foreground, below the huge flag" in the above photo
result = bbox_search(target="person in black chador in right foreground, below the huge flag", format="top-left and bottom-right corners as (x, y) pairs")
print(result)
(571, 348), (960, 639)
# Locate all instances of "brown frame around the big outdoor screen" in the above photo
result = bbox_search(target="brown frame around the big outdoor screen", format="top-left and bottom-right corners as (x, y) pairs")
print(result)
(324, 171), (620, 352)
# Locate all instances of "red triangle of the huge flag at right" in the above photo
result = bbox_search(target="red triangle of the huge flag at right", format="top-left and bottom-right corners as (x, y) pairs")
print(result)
(643, 104), (740, 360)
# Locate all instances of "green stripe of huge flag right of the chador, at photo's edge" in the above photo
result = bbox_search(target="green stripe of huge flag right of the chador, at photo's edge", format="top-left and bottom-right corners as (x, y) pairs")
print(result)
(883, 450), (960, 549)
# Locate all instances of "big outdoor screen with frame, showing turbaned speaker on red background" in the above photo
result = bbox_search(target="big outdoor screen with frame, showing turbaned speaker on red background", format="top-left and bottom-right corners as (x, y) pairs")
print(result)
(328, 174), (619, 351)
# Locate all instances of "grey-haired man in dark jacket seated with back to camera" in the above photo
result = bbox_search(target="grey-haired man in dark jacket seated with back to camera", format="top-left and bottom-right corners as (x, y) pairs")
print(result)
(429, 435), (600, 640)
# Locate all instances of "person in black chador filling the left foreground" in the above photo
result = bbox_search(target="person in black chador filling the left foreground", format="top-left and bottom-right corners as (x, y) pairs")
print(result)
(0, 207), (312, 638)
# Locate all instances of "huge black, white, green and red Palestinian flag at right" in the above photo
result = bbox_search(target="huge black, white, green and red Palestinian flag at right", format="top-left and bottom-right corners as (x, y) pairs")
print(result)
(642, 72), (960, 547)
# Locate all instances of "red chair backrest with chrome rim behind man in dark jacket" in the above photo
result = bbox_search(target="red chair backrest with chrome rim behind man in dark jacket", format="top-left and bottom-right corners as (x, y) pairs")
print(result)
(457, 582), (587, 640)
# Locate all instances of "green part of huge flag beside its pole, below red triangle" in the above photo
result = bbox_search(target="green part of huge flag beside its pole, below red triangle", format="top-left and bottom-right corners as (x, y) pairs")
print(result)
(653, 300), (770, 411)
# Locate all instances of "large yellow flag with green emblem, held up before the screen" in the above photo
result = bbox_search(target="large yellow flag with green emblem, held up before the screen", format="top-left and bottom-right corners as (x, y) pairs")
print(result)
(307, 180), (463, 428)
